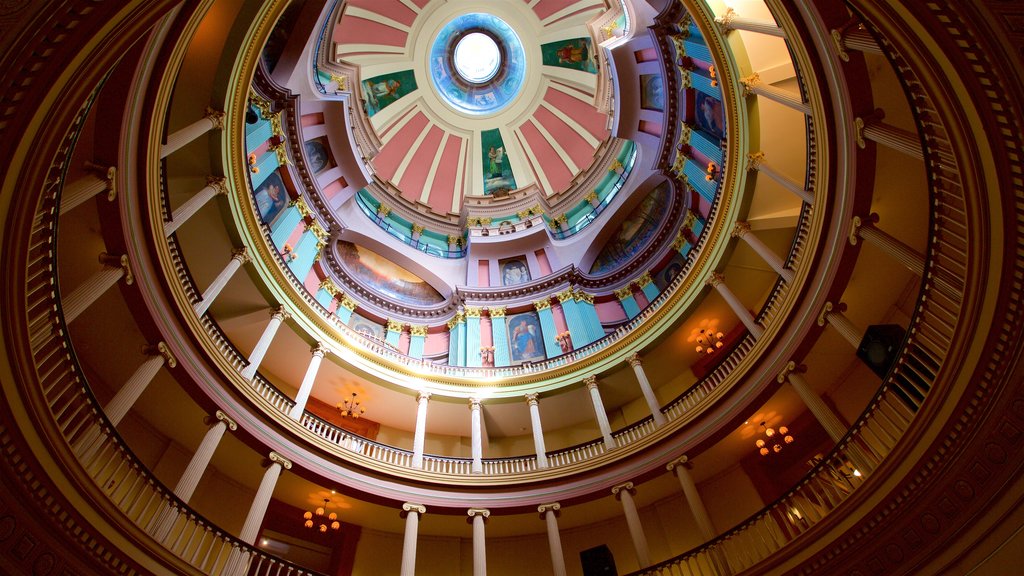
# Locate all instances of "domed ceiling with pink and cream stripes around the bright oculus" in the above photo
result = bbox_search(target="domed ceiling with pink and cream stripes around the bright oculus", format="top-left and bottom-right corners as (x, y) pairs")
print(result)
(331, 0), (609, 216)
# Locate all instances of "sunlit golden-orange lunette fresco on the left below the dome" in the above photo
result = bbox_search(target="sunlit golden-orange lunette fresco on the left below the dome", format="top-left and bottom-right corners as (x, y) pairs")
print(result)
(338, 241), (444, 305)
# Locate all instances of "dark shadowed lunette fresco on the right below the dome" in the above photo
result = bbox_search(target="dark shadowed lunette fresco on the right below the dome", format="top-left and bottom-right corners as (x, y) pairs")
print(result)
(590, 181), (671, 274)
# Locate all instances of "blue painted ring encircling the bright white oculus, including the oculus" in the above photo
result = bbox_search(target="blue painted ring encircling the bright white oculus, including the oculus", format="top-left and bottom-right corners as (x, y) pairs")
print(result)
(430, 12), (526, 116)
